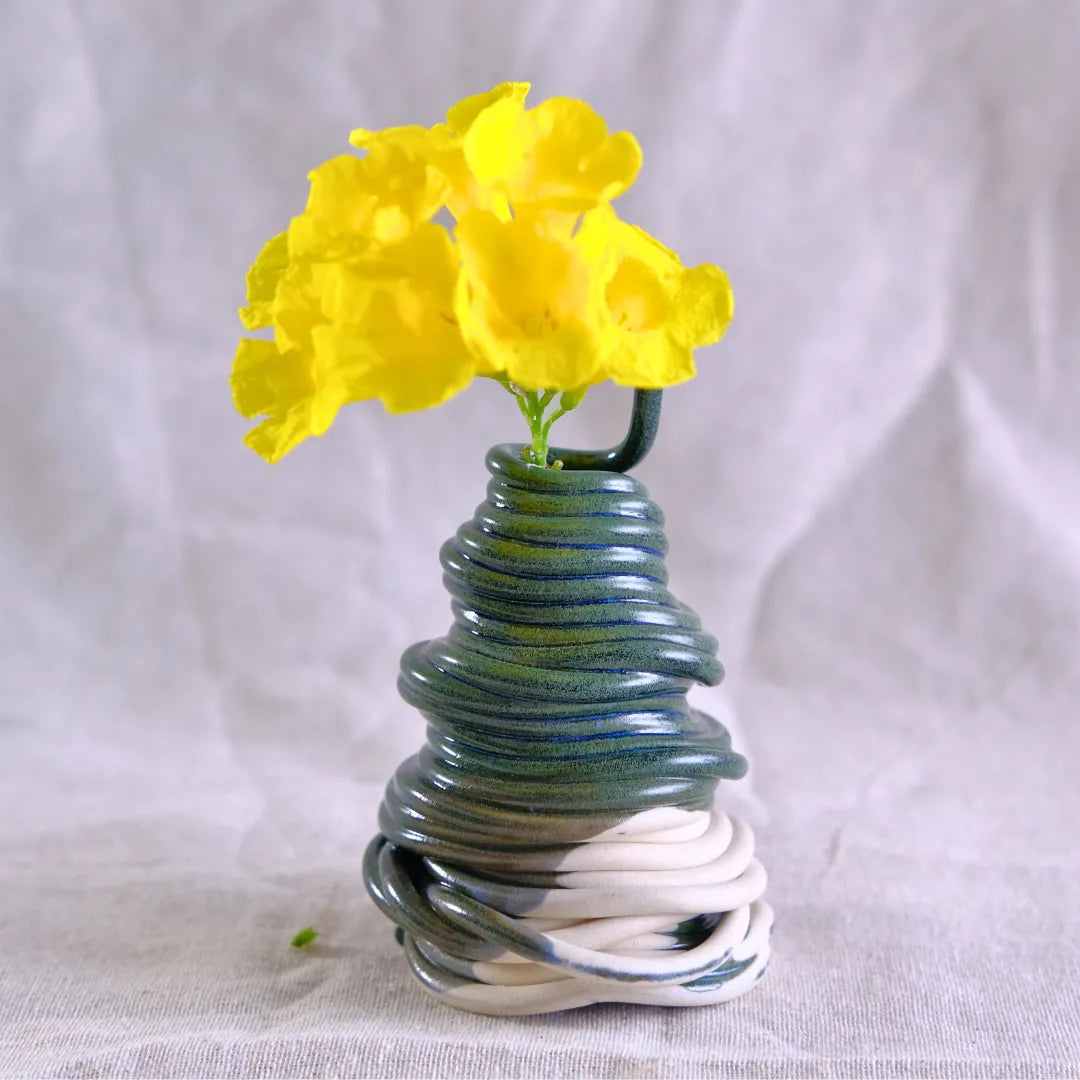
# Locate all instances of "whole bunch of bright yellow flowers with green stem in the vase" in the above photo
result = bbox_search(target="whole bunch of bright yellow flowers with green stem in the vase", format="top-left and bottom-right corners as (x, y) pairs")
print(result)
(231, 83), (731, 461)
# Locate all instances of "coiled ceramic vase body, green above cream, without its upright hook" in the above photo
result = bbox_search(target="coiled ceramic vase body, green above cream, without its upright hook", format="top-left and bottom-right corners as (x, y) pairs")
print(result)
(364, 445), (772, 1014)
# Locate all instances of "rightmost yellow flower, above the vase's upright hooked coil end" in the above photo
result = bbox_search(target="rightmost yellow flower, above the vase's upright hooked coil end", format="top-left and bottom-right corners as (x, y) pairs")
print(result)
(576, 206), (732, 390)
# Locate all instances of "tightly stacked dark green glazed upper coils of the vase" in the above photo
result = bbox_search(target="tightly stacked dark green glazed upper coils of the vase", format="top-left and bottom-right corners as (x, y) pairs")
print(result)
(379, 446), (746, 870)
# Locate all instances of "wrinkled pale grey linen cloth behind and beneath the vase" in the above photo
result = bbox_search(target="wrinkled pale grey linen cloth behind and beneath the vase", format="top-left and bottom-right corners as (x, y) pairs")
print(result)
(0, 0), (1080, 1077)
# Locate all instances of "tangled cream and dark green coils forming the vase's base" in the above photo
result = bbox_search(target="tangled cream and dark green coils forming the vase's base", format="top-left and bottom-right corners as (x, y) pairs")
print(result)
(365, 809), (772, 1015)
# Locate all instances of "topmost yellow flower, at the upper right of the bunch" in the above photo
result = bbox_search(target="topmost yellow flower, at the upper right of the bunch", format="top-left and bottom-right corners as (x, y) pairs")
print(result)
(464, 96), (642, 214)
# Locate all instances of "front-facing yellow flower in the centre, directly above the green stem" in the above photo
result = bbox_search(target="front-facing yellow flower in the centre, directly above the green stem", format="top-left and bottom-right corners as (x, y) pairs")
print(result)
(455, 211), (603, 390)
